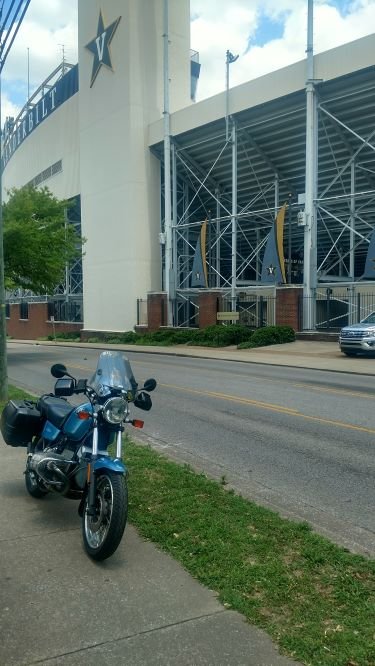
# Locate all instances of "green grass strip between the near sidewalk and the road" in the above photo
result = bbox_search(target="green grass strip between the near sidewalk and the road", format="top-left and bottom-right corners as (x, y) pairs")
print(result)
(2, 387), (375, 666)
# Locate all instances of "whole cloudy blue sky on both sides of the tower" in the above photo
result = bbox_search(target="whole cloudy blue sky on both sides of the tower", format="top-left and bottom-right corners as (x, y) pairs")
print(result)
(1, 0), (375, 122)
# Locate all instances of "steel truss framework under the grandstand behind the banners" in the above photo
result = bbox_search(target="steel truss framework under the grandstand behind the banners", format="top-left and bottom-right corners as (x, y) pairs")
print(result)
(152, 61), (375, 328)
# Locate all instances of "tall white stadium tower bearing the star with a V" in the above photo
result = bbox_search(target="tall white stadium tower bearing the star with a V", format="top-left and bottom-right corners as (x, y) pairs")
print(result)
(79, 0), (190, 331)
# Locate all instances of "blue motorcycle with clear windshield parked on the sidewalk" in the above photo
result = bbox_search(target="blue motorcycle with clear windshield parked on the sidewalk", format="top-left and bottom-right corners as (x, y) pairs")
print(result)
(0, 351), (156, 560)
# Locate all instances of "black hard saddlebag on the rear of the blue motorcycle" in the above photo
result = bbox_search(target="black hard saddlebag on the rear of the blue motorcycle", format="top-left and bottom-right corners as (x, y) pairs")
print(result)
(0, 400), (43, 446)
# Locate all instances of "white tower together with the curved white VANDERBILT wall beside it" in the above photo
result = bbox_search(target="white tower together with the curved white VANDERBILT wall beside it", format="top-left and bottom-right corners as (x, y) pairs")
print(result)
(3, 0), (191, 331)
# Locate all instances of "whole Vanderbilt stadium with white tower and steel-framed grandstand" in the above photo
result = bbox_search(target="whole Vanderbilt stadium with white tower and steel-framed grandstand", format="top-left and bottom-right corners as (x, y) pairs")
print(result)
(2, 0), (375, 337)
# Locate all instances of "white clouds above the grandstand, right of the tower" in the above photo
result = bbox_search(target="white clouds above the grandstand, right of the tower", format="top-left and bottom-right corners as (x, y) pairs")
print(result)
(191, 0), (375, 100)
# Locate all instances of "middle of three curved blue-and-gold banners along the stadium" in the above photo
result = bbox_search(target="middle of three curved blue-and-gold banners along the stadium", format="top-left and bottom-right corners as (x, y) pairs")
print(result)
(260, 204), (286, 284)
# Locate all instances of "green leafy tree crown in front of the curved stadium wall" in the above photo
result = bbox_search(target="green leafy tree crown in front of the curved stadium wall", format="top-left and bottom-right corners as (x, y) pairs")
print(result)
(3, 185), (82, 293)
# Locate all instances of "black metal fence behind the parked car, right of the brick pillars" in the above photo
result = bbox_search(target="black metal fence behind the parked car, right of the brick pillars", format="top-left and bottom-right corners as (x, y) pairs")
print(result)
(299, 289), (375, 332)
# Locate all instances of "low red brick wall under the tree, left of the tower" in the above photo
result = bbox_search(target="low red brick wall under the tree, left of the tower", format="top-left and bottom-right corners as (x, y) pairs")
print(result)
(6, 303), (82, 340)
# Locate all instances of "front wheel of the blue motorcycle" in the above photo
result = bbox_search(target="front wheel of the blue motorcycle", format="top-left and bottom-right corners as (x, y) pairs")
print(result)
(82, 470), (128, 560)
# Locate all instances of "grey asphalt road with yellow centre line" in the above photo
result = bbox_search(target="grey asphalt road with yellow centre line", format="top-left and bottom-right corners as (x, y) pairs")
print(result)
(8, 344), (375, 556)
